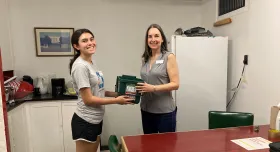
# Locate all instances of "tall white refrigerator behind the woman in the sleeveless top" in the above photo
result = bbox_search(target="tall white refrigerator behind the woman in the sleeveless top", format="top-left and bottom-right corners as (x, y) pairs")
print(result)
(171, 35), (228, 131)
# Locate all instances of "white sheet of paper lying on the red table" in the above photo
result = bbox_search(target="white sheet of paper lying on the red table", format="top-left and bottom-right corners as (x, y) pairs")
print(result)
(231, 137), (271, 150)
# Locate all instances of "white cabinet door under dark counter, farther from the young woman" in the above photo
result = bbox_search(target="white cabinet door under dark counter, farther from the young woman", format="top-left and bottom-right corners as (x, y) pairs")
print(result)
(28, 101), (64, 152)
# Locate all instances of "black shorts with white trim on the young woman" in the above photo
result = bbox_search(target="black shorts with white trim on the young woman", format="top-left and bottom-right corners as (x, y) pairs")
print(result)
(71, 113), (103, 142)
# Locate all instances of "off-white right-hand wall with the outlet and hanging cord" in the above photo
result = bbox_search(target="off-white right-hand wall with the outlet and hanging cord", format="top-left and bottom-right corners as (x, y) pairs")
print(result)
(201, 0), (280, 124)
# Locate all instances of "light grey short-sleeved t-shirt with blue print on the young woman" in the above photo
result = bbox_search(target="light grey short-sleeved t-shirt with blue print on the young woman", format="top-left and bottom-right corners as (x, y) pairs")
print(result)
(71, 57), (105, 124)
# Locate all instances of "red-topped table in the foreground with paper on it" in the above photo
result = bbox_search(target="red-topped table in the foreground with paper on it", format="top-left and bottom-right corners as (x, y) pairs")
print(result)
(121, 125), (276, 152)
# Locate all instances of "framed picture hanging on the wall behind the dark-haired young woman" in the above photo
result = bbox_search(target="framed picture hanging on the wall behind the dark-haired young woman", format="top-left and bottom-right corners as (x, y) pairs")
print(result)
(34, 27), (74, 57)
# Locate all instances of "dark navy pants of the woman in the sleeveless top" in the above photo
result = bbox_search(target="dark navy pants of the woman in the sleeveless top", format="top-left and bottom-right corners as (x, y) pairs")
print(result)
(141, 107), (177, 134)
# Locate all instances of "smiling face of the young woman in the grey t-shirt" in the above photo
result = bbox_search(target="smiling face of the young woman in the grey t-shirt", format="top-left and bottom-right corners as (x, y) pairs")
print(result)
(74, 33), (96, 56)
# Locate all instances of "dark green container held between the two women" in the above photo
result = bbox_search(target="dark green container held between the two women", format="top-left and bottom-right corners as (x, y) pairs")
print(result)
(115, 75), (144, 104)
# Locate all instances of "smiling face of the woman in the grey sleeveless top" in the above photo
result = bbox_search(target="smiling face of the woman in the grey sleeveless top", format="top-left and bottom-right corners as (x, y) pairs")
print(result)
(147, 28), (163, 50)
